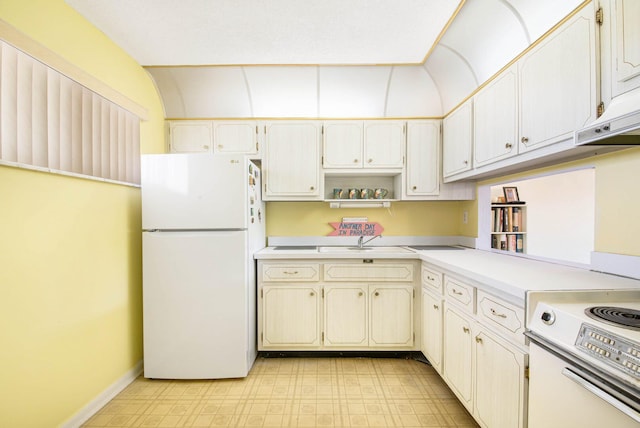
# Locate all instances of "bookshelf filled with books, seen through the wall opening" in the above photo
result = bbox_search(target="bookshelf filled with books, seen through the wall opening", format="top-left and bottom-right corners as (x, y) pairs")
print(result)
(491, 203), (527, 253)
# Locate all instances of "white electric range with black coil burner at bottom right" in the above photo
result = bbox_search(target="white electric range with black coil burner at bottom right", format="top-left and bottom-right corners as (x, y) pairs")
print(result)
(526, 288), (640, 428)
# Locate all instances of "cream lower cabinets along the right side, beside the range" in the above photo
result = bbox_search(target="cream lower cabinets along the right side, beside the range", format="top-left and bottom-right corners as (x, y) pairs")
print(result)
(436, 268), (528, 428)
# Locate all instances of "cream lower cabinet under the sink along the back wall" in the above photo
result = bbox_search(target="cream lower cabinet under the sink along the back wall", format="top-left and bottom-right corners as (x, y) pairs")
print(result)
(258, 260), (420, 351)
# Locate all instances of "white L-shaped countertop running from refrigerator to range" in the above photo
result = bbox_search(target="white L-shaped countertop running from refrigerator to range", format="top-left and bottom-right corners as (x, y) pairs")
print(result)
(255, 247), (640, 305)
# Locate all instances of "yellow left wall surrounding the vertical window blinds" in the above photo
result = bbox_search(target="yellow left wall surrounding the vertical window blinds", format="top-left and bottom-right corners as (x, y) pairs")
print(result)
(0, 0), (164, 427)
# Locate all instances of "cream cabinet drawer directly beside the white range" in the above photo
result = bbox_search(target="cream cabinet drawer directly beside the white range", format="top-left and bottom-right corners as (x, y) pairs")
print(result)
(478, 290), (525, 344)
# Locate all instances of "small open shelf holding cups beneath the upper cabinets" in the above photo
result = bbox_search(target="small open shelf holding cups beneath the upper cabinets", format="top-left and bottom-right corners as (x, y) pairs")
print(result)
(324, 170), (402, 208)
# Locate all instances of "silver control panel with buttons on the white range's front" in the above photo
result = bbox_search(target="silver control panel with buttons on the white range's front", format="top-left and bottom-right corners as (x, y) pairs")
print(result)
(576, 324), (640, 379)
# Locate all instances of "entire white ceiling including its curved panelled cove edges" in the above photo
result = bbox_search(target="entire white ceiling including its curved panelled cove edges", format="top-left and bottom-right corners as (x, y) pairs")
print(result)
(65, 0), (583, 118)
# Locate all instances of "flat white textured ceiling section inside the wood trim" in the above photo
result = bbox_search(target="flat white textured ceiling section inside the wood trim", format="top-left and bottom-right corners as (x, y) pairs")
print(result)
(66, 0), (461, 65)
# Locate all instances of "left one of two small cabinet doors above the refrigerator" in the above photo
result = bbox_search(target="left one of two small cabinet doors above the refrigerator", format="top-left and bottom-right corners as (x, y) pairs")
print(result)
(169, 120), (213, 153)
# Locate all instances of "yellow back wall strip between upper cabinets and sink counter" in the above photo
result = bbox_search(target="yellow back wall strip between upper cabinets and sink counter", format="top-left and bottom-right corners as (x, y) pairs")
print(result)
(267, 201), (470, 236)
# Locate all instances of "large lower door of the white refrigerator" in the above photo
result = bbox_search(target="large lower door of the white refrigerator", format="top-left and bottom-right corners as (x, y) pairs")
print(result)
(142, 231), (256, 379)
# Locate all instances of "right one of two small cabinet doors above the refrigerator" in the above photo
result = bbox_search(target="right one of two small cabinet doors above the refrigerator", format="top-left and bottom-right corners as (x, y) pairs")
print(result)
(213, 121), (259, 154)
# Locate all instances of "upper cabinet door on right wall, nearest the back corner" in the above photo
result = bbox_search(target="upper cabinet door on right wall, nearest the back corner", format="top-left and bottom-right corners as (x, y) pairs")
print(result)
(442, 100), (473, 177)
